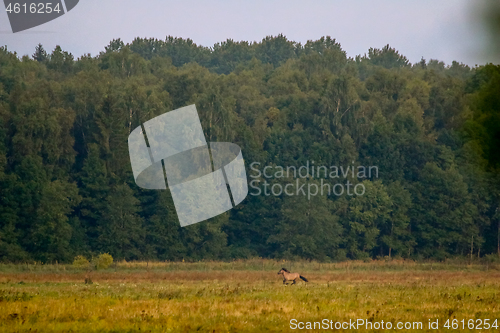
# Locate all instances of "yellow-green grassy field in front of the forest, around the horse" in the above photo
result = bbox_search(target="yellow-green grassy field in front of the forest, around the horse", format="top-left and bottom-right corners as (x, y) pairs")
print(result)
(0, 260), (500, 332)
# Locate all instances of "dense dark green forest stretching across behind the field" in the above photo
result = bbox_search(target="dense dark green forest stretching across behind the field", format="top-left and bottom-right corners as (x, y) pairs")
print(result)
(0, 35), (500, 262)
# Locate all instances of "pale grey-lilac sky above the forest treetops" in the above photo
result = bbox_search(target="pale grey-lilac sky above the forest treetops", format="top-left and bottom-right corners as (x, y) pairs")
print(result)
(0, 0), (498, 66)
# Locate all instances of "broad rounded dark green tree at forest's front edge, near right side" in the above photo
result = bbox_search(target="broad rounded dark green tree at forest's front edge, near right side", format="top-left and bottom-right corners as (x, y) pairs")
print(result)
(410, 163), (482, 259)
